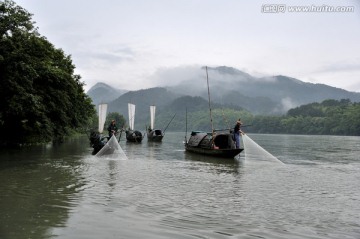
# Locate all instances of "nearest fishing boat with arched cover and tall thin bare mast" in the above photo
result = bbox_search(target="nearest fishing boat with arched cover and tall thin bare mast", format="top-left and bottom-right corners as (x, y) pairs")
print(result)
(184, 67), (244, 158)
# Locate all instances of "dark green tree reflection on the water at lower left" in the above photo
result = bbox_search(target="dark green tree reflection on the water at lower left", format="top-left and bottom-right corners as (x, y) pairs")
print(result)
(0, 138), (88, 238)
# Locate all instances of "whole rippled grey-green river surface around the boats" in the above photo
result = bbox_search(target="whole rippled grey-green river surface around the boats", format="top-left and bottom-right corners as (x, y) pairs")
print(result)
(0, 132), (360, 239)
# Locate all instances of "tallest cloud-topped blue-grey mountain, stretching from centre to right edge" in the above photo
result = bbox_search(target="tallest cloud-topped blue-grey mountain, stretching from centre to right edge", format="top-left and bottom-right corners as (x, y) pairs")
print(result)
(168, 66), (360, 114)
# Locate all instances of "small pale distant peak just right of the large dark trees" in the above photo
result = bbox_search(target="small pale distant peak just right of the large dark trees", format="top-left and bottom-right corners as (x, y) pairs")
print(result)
(86, 82), (127, 105)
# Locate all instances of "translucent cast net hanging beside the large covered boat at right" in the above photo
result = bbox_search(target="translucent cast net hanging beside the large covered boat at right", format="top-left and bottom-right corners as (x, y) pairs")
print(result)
(242, 134), (283, 164)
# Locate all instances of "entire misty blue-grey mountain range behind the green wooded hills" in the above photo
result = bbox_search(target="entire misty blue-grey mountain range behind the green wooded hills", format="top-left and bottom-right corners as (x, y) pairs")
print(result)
(88, 66), (360, 118)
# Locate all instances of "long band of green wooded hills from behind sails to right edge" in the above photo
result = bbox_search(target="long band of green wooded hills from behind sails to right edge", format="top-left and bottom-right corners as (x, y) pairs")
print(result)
(158, 97), (360, 136)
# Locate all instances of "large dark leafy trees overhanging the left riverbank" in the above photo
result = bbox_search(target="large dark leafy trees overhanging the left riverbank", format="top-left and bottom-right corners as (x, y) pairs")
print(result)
(0, 0), (95, 145)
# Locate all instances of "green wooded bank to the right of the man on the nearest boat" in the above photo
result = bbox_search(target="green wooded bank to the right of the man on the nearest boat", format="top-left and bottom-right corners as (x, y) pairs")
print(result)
(236, 100), (360, 136)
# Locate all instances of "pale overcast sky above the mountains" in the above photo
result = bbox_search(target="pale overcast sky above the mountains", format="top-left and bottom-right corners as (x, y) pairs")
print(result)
(15, 0), (360, 92)
